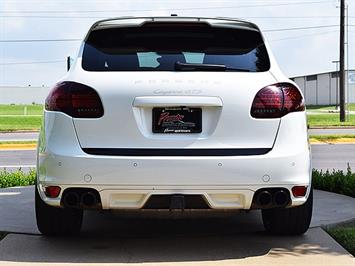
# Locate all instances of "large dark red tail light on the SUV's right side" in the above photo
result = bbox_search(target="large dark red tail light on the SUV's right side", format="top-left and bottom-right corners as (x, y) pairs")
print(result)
(250, 83), (305, 118)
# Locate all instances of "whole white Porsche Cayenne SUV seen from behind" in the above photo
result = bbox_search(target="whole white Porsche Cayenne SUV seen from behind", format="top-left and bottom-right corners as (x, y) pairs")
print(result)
(36, 17), (312, 235)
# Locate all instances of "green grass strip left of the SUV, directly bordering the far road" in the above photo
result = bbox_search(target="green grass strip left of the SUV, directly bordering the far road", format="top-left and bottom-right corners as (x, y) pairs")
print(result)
(0, 116), (42, 131)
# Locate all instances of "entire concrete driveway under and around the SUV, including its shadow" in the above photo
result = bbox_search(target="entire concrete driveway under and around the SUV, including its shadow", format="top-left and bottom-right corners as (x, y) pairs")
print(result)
(0, 187), (355, 266)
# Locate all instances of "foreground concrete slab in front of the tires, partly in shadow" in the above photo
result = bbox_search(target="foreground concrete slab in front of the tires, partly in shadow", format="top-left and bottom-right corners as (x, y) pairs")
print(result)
(0, 226), (355, 266)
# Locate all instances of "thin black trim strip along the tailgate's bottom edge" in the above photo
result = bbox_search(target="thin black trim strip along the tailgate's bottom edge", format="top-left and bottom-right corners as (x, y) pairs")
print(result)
(83, 148), (271, 156)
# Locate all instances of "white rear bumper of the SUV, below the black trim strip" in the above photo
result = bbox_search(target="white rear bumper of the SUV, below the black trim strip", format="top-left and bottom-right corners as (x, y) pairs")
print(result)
(37, 113), (311, 209)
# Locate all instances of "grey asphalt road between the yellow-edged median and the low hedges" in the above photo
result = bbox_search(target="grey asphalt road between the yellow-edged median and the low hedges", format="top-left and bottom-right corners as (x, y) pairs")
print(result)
(0, 144), (355, 170)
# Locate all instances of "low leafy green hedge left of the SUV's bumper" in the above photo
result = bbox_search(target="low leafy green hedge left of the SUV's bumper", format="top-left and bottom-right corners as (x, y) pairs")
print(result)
(0, 169), (36, 188)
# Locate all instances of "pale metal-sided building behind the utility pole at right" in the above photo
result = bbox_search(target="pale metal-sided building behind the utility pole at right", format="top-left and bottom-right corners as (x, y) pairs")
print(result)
(292, 70), (355, 105)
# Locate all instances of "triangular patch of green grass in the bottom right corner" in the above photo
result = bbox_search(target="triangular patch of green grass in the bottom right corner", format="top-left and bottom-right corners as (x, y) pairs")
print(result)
(327, 225), (355, 256)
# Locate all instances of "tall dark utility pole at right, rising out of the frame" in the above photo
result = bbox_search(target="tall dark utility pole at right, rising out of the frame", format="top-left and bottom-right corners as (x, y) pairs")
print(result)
(339, 0), (345, 122)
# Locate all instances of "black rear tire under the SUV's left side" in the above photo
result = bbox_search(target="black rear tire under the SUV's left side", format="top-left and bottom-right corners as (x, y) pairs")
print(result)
(35, 186), (83, 236)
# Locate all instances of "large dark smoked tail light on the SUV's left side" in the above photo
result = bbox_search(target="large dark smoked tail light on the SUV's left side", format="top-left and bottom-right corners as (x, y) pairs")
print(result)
(45, 81), (104, 118)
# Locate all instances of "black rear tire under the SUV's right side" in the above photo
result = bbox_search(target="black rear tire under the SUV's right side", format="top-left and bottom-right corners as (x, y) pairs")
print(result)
(262, 188), (313, 235)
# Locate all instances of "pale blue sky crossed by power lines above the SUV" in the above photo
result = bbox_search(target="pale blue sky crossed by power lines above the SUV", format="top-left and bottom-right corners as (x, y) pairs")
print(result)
(0, 0), (355, 86)
